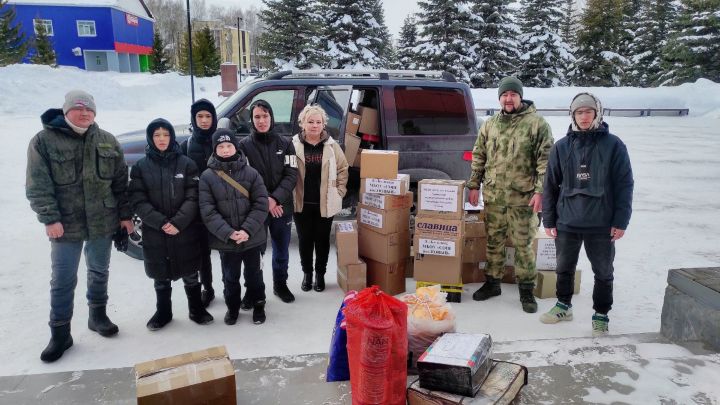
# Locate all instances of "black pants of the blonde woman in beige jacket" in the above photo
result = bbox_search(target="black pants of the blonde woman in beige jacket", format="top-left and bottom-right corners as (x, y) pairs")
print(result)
(294, 204), (333, 274)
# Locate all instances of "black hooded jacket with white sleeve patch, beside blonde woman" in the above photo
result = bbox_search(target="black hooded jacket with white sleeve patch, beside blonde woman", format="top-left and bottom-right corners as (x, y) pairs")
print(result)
(240, 100), (298, 210)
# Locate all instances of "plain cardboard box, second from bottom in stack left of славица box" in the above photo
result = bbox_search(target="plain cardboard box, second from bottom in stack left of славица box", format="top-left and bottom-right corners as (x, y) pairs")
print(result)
(358, 228), (410, 263)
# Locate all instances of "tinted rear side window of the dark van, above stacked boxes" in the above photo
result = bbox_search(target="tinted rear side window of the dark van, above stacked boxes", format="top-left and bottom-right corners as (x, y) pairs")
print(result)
(395, 86), (470, 135)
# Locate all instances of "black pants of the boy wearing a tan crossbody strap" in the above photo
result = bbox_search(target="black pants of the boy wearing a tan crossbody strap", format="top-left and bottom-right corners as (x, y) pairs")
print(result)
(220, 246), (265, 304)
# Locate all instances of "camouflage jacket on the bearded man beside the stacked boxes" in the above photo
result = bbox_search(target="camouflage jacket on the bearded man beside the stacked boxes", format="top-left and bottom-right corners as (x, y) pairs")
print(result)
(468, 100), (553, 206)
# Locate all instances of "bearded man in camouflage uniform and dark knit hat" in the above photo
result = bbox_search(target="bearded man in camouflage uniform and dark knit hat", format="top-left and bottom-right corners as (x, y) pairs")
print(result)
(468, 77), (553, 313)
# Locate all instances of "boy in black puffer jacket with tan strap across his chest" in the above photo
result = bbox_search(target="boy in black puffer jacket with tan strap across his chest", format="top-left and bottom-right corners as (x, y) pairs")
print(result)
(200, 129), (268, 325)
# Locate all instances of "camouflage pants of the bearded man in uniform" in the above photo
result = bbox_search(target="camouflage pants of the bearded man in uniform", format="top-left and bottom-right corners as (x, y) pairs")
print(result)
(485, 205), (539, 284)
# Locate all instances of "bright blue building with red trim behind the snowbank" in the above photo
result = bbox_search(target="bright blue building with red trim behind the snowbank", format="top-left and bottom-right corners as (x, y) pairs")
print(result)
(8, 0), (155, 72)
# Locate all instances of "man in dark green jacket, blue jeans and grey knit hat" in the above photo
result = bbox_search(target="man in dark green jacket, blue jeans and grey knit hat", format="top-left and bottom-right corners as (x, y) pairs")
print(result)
(25, 90), (133, 362)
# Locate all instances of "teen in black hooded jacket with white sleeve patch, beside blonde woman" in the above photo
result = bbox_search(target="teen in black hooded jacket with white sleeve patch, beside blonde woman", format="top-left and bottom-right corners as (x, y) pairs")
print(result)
(240, 100), (297, 309)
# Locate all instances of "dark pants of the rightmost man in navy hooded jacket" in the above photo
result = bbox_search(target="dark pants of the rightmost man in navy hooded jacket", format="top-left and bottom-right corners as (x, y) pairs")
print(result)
(555, 231), (615, 314)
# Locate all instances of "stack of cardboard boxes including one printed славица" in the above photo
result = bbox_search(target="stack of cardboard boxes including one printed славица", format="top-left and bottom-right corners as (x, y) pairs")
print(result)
(413, 179), (465, 302)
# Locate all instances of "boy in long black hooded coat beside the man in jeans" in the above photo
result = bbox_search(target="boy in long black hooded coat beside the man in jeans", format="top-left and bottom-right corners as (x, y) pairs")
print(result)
(129, 118), (213, 331)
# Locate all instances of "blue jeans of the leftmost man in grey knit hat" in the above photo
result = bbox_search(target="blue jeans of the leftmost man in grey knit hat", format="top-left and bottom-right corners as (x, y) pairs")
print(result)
(49, 236), (112, 327)
